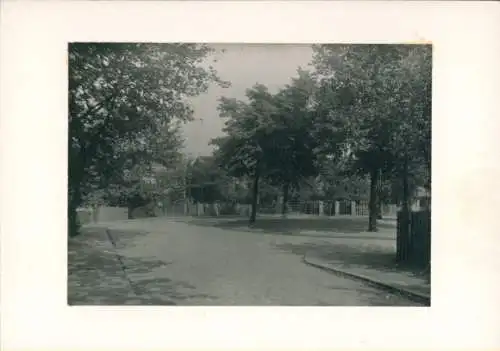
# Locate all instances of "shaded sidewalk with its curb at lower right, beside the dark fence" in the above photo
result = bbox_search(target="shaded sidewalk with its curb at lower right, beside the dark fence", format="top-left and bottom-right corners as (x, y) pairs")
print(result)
(303, 245), (431, 306)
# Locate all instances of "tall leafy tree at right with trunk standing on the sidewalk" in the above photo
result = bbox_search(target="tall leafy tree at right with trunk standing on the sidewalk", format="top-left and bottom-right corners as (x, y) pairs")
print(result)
(313, 45), (430, 231)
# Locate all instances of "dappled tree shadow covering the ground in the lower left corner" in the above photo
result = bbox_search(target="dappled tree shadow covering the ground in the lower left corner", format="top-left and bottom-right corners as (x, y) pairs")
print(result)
(67, 232), (215, 306)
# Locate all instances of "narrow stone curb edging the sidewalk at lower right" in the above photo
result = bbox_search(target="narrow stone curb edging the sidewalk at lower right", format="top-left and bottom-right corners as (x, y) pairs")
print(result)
(302, 255), (431, 306)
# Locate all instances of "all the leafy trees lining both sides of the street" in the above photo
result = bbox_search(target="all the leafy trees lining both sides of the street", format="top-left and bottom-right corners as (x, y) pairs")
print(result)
(68, 43), (431, 234)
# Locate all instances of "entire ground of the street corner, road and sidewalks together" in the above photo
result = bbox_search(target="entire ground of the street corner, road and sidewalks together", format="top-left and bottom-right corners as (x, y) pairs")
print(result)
(68, 217), (430, 306)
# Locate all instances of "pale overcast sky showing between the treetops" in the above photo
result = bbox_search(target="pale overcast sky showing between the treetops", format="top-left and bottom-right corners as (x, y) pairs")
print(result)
(184, 44), (312, 156)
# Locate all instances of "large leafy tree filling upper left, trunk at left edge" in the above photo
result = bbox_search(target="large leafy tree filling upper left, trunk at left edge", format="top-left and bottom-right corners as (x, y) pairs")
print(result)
(68, 43), (227, 234)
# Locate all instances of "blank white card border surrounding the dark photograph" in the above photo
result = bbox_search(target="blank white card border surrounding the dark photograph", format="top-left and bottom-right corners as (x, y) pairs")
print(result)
(0, 1), (500, 350)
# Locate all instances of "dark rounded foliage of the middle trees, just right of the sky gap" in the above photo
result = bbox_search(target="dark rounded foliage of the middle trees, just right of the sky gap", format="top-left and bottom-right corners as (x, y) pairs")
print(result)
(214, 69), (318, 219)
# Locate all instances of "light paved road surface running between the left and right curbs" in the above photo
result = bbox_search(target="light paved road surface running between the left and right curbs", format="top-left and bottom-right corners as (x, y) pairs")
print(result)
(70, 219), (422, 306)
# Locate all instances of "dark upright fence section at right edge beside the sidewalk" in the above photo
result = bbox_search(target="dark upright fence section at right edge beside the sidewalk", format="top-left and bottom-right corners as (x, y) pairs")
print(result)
(396, 211), (431, 268)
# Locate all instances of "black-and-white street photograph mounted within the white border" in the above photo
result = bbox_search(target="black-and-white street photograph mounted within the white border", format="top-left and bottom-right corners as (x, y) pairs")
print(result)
(67, 42), (432, 306)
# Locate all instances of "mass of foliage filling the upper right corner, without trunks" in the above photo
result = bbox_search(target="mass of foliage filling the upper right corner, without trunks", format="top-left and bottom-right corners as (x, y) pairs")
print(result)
(314, 45), (432, 176)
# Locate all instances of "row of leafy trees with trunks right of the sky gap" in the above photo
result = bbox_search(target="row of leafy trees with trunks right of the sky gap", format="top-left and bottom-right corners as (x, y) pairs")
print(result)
(213, 45), (432, 231)
